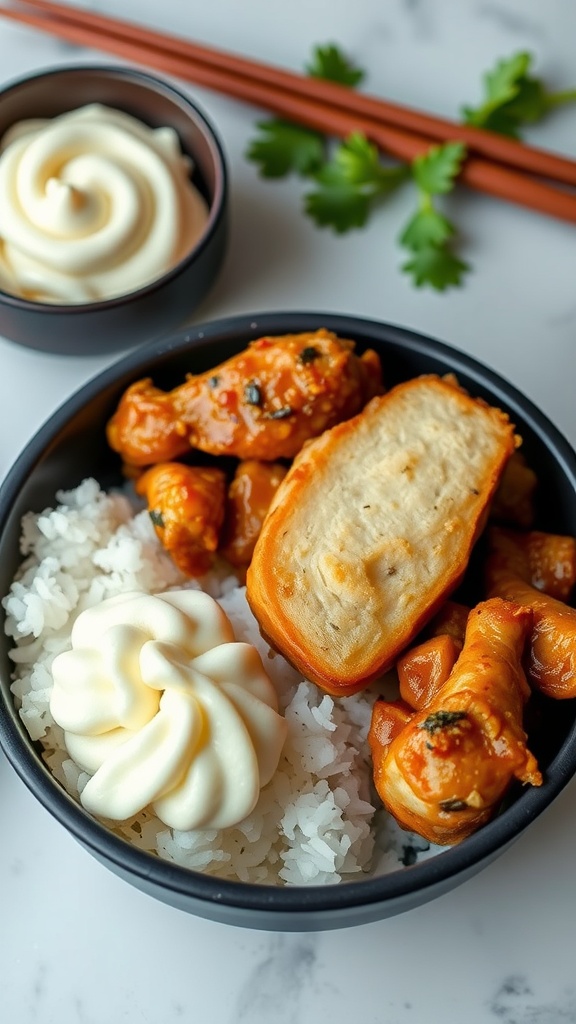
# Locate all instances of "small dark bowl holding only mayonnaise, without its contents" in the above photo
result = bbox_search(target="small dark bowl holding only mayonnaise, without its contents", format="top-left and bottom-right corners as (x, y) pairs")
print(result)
(0, 66), (228, 355)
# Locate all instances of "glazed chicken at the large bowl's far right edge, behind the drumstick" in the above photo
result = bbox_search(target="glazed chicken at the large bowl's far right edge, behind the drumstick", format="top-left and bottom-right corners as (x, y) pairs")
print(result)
(486, 526), (576, 699)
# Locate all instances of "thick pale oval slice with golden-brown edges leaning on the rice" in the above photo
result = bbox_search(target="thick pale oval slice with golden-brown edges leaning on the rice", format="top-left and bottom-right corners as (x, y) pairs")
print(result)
(247, 375), (517, 695)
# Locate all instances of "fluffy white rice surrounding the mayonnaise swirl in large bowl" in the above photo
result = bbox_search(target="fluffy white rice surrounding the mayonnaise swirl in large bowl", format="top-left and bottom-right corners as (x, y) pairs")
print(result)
(2, 479), (435, 886)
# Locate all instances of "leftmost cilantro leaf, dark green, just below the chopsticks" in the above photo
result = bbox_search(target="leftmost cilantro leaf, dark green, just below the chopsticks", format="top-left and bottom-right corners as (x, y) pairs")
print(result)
(246, 118), (325, 178)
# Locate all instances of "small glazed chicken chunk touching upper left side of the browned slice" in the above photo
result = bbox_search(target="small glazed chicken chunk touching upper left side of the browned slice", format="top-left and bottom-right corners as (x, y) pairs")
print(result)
(221, 459), (288, 568)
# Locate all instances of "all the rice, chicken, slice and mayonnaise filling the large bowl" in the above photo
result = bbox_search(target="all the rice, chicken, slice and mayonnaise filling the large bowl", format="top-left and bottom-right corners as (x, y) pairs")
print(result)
(3, 330), (576, 885)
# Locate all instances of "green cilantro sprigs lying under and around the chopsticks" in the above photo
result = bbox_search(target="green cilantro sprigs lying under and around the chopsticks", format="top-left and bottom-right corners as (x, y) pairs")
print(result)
(242, 44), (576, 291)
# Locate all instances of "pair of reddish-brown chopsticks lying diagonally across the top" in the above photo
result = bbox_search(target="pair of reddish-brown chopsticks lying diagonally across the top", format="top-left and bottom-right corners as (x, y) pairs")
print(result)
(0, 0), (576, 223)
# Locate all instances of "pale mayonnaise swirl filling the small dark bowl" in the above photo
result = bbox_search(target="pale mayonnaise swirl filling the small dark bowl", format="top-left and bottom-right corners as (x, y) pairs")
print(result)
(0, 103), (208, 303)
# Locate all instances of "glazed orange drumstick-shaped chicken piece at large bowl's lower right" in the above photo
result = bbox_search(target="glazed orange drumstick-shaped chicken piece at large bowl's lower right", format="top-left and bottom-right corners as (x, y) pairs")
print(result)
(368, 598), (542, 845)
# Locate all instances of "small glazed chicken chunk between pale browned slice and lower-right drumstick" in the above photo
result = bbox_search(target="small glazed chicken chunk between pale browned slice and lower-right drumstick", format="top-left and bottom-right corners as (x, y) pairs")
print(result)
(396, 601), (470, 710)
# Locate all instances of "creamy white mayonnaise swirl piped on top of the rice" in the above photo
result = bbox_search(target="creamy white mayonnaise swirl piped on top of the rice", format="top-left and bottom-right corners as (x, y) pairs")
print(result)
(50, 590), (287, 830)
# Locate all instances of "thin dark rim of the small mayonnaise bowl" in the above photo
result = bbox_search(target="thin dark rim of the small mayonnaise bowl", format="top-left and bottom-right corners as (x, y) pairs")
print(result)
(0, 63), (229, 316)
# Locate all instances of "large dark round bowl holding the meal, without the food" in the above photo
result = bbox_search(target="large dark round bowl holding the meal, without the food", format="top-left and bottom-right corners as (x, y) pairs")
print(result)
(0, 312), (576, 931)
